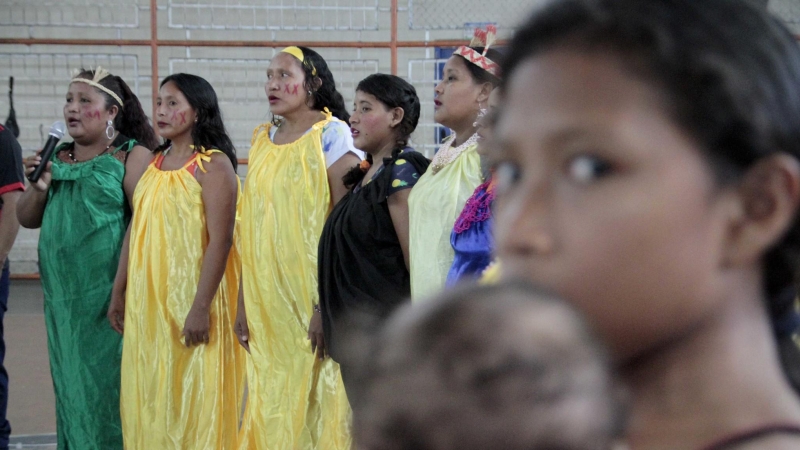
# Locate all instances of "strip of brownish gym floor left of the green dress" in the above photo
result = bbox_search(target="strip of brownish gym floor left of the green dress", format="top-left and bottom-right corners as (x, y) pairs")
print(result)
(3, 280), (56, 450)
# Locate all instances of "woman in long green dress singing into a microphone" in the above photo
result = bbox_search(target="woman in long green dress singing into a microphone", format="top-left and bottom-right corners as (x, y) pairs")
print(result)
(17, 67), (157, 450)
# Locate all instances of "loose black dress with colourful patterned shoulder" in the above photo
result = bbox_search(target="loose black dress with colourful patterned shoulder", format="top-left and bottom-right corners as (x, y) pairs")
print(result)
(318, 148), (429, 366)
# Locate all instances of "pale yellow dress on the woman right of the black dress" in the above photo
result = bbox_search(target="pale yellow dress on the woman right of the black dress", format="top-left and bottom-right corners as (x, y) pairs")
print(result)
(408, 140), (481, 301)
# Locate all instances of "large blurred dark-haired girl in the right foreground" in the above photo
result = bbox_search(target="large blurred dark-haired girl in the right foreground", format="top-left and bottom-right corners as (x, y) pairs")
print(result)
(492, 0), (800, 450)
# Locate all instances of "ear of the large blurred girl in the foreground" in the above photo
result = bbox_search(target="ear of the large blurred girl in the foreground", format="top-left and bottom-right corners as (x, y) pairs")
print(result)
(725, 153), (800, 266)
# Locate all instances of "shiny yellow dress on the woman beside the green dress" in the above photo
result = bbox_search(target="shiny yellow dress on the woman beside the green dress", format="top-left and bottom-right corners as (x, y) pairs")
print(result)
(120, 149), (244, 450)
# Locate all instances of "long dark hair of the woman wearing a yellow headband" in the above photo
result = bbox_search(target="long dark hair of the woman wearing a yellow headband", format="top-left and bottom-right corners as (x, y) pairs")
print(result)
(297, 47), (350, 122)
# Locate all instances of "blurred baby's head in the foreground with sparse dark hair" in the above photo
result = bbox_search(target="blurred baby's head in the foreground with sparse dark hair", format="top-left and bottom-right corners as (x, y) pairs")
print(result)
(348, 283), (623, 450)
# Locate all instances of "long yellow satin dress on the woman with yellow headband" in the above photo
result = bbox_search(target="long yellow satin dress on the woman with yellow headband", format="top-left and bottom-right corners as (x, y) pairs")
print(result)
(240, 110), (351, 450)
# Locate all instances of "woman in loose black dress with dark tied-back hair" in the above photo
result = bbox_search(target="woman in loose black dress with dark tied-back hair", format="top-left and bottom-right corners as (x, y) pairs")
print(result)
(309, 74), (428, 390)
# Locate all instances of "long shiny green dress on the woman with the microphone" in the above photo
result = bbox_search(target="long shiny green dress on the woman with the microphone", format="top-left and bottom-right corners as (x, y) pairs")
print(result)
(39, 136), (136, 450)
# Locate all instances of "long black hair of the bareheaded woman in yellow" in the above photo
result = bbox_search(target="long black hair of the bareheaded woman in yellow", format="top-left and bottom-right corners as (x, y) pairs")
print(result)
(158, 73), (238, 170)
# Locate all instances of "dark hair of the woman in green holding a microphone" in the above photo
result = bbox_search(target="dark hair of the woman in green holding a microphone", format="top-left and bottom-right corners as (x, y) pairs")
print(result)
(78, 69), (158, 150)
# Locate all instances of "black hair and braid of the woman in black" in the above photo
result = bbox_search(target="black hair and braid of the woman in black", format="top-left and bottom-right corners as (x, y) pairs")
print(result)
(342, 73), (420, 187)
